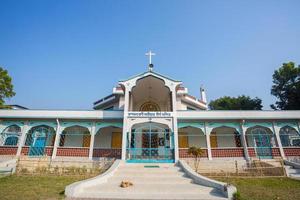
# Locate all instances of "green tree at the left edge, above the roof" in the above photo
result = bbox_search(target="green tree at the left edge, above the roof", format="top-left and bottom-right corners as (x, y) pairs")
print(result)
(0, 67), (16, 108)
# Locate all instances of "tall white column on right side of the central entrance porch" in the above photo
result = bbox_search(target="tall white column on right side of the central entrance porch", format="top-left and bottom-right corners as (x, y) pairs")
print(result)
(172, 86), (179, 162)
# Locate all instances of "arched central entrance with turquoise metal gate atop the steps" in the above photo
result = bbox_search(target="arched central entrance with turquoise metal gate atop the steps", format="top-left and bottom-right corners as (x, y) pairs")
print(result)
(127, 123), (174, 163)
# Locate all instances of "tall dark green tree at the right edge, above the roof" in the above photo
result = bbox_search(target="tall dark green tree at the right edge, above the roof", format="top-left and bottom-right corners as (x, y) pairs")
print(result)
(271, 62), (300, 110)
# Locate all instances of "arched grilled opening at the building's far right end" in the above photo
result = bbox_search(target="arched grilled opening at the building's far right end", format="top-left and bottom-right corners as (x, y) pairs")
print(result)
(279, 126), (300, 147)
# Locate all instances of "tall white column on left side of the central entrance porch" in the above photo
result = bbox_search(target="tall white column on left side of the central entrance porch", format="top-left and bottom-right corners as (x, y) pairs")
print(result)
(122, 87), (129, 160)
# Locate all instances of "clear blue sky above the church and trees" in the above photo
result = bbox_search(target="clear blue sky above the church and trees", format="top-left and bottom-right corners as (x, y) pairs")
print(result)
(0, 0), (300, 109)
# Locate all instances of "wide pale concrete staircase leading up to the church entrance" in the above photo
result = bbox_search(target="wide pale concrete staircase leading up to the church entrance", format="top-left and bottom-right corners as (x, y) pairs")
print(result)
(69, 163), (227, 200)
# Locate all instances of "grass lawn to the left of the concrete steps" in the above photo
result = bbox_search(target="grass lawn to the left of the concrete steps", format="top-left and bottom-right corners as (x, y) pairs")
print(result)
(0, 175), (84, 200)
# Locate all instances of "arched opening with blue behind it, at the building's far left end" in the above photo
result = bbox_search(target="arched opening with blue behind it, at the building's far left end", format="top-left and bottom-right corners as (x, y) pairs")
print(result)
(0, 125), (21, 146)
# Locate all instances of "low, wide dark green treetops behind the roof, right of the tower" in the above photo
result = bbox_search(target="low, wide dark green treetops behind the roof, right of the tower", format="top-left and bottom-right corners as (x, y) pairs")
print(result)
(209, 95), (263, 110)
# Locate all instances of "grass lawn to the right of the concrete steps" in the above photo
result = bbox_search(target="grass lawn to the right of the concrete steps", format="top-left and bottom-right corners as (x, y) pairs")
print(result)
(218, 178), (300, 200)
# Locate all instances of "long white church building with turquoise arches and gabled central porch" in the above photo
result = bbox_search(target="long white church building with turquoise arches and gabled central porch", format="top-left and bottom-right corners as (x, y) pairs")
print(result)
(0, 56), (300, 163)
